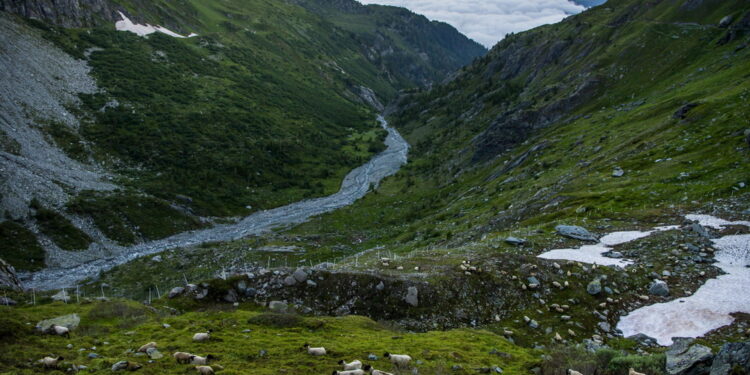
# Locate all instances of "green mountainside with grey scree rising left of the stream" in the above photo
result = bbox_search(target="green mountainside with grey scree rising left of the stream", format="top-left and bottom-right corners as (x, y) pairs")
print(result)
(0, 0), (485, 270)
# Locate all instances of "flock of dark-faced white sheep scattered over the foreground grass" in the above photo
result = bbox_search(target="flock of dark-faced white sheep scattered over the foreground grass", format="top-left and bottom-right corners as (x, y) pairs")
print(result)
(39, 324), (414, 375)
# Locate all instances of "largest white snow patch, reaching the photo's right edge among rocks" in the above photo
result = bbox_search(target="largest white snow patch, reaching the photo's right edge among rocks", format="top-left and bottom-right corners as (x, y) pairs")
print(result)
(617, 235), (750, 345)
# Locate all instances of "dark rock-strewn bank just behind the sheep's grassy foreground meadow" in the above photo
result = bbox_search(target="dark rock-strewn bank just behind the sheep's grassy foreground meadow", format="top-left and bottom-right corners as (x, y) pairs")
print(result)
(173, 269), (532, 331)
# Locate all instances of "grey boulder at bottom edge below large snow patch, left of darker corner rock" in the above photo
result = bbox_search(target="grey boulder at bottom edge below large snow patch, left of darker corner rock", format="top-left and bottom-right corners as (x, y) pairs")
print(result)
(667, 337), (714, 375)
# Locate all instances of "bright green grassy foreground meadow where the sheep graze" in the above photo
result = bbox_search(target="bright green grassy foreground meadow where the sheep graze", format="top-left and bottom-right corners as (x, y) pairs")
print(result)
(0, 300), (539, 375)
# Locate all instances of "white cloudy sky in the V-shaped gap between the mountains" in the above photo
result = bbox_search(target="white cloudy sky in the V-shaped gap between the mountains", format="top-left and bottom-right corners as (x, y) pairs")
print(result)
(360, 0), (585, 48)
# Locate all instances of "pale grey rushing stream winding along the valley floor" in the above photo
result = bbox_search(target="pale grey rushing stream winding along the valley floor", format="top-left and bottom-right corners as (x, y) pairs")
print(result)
(19, 117), (409, 289)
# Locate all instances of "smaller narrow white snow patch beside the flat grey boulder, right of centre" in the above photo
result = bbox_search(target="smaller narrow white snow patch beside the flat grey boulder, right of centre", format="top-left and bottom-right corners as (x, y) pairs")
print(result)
(538, 225), (679, 267)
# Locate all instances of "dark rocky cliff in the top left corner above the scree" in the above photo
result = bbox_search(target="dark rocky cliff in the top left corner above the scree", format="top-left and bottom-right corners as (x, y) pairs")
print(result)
(0, 0), (120, 27)
